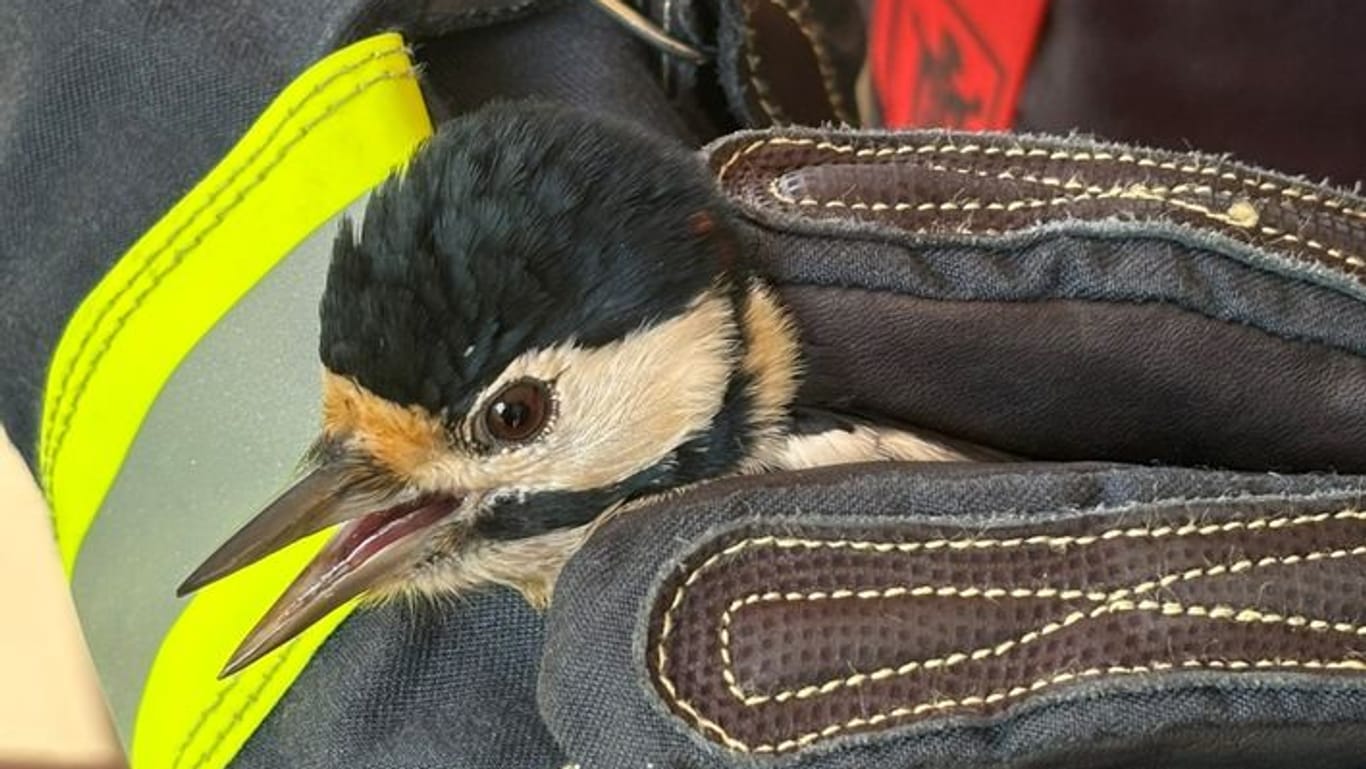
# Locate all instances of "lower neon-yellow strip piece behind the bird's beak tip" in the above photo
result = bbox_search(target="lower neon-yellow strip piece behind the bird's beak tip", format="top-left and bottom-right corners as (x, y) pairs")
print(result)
(130, 531), (354, 769)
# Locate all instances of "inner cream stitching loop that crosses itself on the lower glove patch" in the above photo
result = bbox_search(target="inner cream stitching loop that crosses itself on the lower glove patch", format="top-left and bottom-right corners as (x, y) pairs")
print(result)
(719, 545), (1366, 706)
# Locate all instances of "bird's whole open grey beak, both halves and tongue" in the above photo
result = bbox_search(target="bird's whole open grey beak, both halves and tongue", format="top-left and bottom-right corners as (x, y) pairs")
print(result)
(176, 460), (462, 677)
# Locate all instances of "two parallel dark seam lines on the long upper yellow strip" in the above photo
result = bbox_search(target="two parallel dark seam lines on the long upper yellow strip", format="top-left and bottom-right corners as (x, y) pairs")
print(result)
(42, 55), (417, 493)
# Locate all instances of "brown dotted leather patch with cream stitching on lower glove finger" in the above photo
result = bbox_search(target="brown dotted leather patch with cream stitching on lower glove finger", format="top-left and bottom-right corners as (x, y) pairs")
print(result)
(647, 478), (1366, 754)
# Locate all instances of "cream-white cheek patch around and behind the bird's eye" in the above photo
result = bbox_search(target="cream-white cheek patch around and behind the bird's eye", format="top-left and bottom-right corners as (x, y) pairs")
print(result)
(419, 294), (738, 492)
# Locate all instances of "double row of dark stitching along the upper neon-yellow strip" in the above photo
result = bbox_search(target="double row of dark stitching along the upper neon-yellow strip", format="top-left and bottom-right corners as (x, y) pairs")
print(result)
(42, 48), (415, 494)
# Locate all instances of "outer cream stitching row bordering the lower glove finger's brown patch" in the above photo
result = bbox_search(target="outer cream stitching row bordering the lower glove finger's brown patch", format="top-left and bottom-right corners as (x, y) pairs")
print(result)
(654, 508), (1366, 753)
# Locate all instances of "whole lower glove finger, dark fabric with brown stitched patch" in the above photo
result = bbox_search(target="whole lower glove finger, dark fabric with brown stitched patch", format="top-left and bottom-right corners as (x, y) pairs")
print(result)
(540, 464), (1366, 769)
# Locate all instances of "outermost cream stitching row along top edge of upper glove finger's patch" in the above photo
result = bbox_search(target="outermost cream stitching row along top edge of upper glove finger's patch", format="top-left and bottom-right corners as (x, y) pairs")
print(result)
(717, 137), (1366, 228)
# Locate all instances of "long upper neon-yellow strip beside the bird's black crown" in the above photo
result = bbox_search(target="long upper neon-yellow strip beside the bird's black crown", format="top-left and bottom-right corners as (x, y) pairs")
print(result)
(40, 34), (432, 574)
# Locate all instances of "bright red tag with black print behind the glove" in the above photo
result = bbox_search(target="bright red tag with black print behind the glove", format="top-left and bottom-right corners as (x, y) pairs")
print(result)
(869, 0), (1048, 130)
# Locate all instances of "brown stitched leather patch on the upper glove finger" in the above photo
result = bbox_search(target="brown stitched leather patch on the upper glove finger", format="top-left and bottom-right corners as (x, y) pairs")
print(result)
(712, 131), (1366, 281)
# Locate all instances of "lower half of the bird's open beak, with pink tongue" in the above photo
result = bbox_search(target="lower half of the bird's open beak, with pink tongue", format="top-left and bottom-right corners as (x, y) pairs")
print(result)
(219, 496), (459, 677)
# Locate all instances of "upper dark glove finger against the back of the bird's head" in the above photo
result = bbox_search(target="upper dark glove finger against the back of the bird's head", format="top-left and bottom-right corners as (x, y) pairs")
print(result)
(709, 128), (1366, 471)
